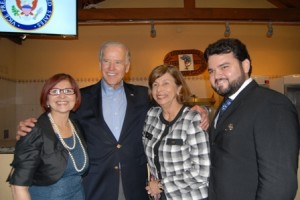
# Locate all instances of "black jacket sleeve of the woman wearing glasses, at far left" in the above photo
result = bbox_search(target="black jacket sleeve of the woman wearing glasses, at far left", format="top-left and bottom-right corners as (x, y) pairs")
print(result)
(8, 126), (43, 186)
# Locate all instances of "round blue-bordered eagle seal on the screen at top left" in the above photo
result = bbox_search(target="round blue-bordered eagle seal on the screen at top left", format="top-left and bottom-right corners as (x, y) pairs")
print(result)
(0, 0), (53, 31)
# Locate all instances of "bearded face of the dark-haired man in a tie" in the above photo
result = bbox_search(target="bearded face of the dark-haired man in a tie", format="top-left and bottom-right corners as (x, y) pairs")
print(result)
(207, 52), (250, 97)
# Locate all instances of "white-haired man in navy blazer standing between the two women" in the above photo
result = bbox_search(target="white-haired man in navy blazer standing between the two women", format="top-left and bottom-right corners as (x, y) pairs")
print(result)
(75, 42), (150, 200)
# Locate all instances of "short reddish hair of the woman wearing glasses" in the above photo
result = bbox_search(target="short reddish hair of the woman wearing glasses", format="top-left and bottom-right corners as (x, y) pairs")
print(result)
(40, 73), (81, 112)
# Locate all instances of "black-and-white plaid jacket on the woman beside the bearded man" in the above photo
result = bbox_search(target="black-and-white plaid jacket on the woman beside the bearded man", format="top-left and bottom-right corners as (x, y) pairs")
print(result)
(143, 107), (210, 200)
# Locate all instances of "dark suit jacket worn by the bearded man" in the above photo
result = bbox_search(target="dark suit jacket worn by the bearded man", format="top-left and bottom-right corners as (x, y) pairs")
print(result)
(209, 81), (299, 200)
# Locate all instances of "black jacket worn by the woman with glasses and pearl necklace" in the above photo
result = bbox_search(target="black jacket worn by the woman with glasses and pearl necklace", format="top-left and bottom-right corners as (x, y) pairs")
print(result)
(8, 113), (86, 186)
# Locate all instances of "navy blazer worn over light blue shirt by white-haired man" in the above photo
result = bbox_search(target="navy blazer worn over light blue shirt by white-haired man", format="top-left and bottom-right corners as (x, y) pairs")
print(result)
(75, 82), (150, 200)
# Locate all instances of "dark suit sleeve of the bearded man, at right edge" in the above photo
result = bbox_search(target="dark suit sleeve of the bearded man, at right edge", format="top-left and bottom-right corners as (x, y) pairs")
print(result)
(254, 97), (299, 200)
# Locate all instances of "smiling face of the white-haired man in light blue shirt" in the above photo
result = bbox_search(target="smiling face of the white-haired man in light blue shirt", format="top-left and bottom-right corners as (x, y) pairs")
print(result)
(100, 45), (130, 89)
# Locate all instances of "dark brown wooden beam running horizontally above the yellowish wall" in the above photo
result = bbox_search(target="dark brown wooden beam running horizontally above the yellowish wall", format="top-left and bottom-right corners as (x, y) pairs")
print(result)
(78, 7), (300, 23)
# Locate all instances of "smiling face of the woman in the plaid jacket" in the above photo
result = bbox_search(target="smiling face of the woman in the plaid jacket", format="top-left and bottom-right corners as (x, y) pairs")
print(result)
(151, 73), (182, 108)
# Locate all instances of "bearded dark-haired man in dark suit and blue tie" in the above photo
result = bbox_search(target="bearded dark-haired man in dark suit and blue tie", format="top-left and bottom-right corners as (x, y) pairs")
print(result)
(204, 39), (299, 200)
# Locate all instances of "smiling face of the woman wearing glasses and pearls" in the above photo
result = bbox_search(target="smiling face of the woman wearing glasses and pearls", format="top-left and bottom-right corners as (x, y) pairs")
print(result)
(47, 80), (76, 114)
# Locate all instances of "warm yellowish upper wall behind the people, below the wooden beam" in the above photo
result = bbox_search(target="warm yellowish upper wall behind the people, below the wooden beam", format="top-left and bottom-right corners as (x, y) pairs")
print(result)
(12, 24), (300, 80)
